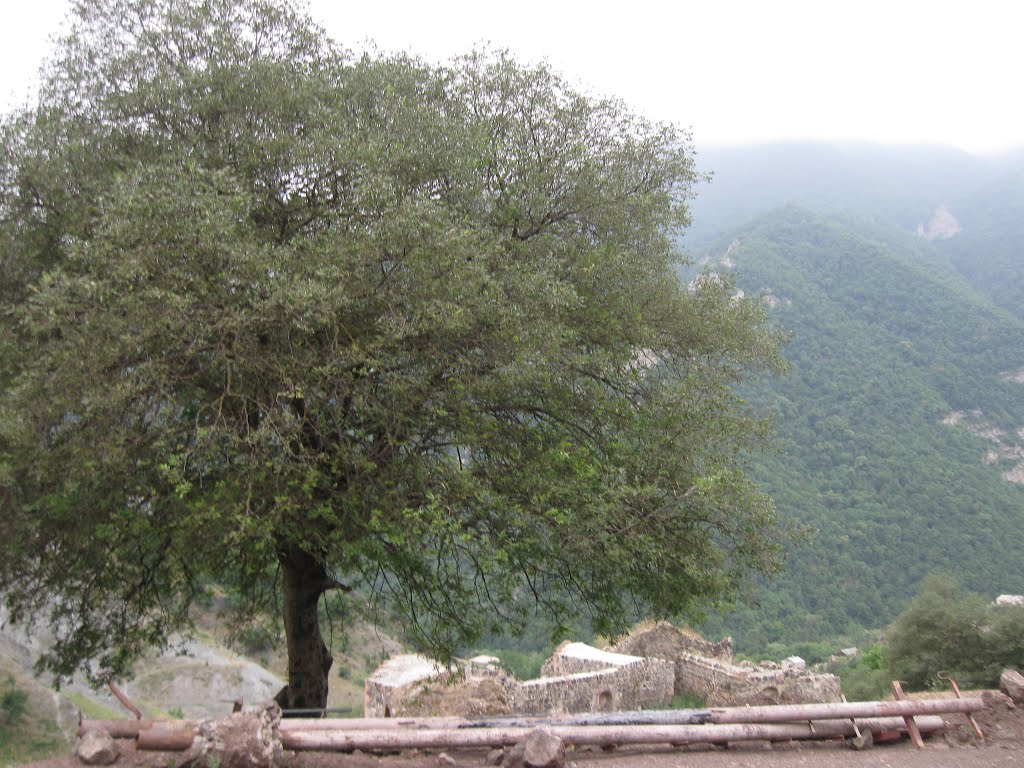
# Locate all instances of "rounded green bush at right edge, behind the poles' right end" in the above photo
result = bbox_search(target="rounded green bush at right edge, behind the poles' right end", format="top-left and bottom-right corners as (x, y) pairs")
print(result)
(887, 575), (1024, 689)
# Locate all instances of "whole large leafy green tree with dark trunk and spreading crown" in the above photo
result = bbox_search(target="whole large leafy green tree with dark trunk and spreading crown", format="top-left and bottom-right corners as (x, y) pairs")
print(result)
(0, 0), (779, 707)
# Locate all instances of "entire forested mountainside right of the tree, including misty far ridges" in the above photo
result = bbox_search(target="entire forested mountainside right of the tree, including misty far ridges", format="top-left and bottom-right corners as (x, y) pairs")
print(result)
(684, 143), (1024, 652)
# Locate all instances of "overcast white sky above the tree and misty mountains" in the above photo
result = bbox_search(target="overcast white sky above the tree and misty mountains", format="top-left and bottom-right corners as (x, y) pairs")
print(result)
(0, 0), (1024, 153)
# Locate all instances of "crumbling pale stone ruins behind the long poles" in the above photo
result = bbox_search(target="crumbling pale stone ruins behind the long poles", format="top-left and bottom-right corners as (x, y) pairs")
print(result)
(365, 622), (841, 718)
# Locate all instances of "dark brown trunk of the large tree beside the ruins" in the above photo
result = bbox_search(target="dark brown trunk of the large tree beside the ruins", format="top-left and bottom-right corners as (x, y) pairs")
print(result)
(275, 547), (335, 710)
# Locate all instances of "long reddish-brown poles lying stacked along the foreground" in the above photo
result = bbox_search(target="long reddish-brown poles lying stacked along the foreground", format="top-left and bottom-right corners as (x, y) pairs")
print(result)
(80, 698), (985, 752)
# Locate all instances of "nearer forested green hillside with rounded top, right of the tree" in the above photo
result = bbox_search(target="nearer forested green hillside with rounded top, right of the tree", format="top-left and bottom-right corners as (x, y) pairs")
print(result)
(709, 207), (1024, 652)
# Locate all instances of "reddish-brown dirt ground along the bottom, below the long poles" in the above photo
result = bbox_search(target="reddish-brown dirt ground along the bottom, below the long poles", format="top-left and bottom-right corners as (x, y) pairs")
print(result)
(18, 693), (1024, 768)
